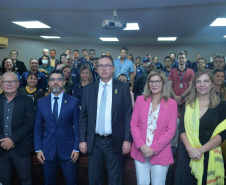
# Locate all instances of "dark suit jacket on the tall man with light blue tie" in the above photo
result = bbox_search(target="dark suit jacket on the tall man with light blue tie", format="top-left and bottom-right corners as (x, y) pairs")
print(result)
(79, 79), (132, 153)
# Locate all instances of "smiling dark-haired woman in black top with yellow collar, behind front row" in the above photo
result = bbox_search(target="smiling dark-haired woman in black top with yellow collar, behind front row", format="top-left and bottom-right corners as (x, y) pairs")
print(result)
(19, 73), (44, 107)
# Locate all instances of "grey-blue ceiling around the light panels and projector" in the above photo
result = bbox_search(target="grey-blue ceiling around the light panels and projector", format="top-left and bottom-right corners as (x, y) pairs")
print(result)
(0, 0), (226, 45)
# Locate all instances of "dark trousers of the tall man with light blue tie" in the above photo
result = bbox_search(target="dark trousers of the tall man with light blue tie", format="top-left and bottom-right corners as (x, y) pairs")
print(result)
(89, 135), (124, 185)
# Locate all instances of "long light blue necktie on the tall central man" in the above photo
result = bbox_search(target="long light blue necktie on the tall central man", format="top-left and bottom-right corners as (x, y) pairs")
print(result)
(97, 84), (107, 135)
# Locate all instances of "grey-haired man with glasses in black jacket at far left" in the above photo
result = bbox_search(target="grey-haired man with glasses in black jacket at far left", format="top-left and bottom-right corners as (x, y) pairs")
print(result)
(0, 72), (35, 185)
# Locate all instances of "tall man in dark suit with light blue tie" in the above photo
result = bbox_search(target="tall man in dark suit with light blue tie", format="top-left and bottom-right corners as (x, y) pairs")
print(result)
(79, 55), (132, 185)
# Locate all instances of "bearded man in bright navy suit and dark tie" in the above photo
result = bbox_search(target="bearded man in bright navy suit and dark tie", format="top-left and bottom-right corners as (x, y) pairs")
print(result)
(34, 70), (79, 185)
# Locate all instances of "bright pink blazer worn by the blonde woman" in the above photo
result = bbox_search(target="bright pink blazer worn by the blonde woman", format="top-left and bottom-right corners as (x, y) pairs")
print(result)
(130, 95), (178, 165)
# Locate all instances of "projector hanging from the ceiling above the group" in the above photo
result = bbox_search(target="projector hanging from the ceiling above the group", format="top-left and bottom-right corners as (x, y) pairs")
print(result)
(102, 10), (126, 30)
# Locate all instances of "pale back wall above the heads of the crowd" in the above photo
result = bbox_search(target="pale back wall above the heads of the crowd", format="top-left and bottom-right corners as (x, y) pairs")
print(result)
(0, 37), (226, 67)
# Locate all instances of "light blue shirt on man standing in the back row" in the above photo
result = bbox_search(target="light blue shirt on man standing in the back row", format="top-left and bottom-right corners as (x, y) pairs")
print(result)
(113, 59), (134, 80)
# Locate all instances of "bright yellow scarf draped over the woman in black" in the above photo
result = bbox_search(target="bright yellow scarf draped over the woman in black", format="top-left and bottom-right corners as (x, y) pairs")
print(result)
(184, 98), (226, 185)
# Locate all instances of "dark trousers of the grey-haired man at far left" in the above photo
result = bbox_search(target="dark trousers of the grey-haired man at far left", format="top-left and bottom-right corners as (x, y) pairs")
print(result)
(0, 149), (32, 185)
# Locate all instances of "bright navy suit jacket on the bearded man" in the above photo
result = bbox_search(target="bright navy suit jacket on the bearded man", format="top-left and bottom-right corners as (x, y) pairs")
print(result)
(34, 94), (79, 161)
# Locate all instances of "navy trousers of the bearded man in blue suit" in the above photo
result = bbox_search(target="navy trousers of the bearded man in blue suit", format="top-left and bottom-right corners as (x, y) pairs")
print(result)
(42, 151), (77, 185)
